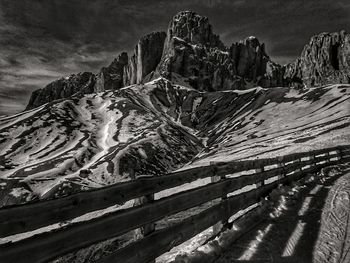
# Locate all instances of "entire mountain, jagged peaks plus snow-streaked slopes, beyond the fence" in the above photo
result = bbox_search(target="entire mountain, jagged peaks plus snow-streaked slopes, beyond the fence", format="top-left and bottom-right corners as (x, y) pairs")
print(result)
(0, 11), (350, 206)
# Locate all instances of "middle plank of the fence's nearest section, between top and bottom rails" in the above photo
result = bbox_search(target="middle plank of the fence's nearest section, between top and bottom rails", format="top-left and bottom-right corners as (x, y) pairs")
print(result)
(0, 175), (258, 263)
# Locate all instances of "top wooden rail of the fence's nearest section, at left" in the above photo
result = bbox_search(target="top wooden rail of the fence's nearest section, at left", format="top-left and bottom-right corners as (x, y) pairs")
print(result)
(0, 167), (215, 237)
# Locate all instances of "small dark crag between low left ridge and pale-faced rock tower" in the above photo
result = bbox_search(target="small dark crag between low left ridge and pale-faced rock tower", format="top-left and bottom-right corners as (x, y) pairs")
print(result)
(95, 52), (128, 91)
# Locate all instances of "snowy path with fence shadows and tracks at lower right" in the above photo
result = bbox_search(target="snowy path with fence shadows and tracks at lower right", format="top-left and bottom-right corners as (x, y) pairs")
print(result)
(215, 166), (350, 263)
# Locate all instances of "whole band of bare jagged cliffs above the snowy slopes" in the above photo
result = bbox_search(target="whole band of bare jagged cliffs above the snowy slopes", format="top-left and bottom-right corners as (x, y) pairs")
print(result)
(27, 11), (350, 109)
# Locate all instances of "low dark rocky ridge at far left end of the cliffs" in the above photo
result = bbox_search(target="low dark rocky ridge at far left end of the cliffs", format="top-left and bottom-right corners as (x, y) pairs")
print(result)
(26, 72), (96, 110)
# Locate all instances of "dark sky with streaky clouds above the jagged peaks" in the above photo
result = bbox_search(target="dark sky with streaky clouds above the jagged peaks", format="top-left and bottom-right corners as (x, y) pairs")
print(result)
(0, 0), (350, 115)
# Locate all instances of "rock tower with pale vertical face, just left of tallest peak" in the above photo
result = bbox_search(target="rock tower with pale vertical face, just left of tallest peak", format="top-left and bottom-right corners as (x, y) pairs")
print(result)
(124, 32), (166, 86)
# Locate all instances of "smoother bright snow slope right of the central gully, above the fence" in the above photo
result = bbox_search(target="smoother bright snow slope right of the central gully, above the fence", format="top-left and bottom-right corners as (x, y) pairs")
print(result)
(183, 85), (350, 166)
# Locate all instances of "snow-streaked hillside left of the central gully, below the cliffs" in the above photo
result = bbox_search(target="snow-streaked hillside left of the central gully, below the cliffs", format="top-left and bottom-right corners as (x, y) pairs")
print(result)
(0, 79), (201, 204)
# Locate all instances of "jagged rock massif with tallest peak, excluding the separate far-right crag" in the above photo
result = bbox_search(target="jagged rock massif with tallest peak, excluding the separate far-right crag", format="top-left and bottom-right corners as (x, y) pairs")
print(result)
(27, 11), (284, 109)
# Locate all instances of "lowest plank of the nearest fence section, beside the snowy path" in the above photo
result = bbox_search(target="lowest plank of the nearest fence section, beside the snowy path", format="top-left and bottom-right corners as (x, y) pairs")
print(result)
(98, 182), (273, 263)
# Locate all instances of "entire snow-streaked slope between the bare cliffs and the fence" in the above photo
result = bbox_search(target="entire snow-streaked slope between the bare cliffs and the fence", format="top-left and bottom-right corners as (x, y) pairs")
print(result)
(0, 78), (350, 205)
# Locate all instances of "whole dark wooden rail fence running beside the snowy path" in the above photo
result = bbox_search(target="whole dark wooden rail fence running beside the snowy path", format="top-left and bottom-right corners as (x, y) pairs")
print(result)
(0, 146), (350, 263)
